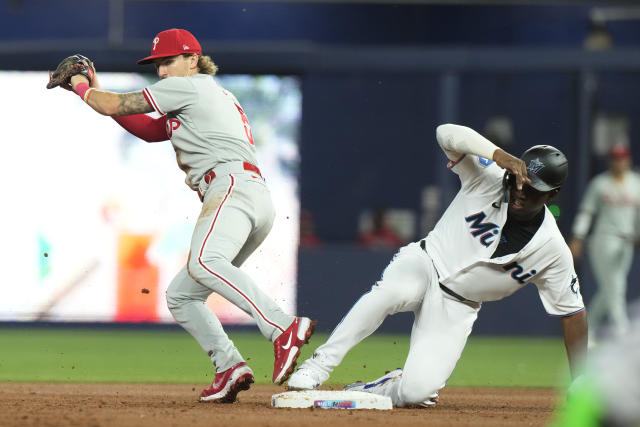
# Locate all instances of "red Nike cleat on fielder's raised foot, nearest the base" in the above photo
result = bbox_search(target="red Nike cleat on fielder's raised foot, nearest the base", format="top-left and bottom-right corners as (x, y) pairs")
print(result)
(273, 317), (318, 384)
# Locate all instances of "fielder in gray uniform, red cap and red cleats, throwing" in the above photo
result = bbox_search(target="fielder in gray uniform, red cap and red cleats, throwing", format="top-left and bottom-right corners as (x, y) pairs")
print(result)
(55, 29), (315, 403)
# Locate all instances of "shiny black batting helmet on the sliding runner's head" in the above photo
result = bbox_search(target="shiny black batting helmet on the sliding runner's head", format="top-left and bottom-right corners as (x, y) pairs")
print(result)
(520, 145), (569, 191)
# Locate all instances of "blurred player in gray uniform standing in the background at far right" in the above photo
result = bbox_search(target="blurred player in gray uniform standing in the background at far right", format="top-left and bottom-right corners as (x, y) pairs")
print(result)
(569, 146), (640, 343)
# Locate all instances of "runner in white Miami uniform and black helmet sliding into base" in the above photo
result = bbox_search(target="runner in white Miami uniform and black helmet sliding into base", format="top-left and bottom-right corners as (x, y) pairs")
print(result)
(288, 124), (587, 406)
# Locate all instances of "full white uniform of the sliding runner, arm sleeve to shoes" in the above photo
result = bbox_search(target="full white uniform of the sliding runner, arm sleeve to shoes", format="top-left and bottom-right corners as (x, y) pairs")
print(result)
(289, 125), (584, 406)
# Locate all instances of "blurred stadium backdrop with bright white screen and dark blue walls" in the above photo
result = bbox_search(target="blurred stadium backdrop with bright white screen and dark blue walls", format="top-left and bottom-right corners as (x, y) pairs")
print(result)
(0, 0), (640, 362)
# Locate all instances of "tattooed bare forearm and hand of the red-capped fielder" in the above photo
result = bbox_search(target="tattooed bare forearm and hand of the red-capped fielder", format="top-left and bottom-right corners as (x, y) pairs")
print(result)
(71, 75), (153, 116)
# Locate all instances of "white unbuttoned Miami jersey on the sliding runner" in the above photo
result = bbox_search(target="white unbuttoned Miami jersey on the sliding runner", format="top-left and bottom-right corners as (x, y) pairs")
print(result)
(425, 155), (584, 316)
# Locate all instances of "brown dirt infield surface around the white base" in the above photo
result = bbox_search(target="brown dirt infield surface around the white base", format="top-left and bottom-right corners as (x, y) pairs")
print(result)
(0, 383), (557, 427)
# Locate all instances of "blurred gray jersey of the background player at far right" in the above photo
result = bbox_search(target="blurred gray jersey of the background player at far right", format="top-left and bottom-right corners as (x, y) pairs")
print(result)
(573, 171), (640, 240)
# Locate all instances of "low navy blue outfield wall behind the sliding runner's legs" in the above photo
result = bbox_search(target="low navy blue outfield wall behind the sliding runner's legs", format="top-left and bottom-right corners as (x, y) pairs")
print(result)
(298, 245), (640, 336)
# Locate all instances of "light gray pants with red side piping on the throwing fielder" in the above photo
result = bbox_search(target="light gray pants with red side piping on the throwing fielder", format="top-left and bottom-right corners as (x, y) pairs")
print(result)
(167, 168), (295, 372)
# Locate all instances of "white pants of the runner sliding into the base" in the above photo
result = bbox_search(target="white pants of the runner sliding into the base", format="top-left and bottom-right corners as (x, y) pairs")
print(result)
(314, 243), (480, 406)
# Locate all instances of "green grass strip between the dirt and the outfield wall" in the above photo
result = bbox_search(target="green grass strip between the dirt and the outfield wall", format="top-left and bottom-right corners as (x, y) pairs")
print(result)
(0, 328), (568, 387)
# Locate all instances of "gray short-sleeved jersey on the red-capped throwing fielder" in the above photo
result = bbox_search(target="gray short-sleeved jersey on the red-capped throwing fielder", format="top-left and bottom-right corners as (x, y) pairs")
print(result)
(142, 74), (256, 190)
